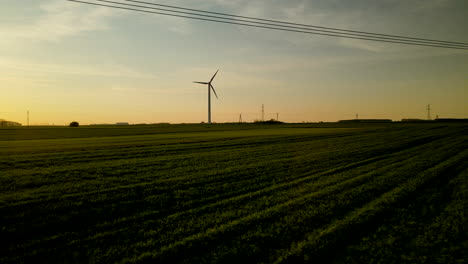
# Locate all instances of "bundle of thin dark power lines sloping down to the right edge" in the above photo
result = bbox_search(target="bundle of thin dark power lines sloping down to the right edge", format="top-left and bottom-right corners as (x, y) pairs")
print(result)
(67, 0), (468, 50)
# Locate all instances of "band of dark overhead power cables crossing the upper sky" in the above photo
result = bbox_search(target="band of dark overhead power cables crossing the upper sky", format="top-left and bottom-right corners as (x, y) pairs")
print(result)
(67, 0), (468, 50)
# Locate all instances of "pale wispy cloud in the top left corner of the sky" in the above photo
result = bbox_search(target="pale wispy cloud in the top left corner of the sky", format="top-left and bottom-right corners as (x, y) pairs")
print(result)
(0, 0), (120, 42)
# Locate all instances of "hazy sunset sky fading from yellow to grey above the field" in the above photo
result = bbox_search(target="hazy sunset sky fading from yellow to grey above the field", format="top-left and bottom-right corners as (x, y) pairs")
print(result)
(0, 0), (468, 125)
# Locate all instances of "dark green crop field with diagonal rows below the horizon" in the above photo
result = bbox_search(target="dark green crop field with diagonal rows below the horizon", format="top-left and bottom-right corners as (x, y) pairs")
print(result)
(0, 123), (468, 263)
